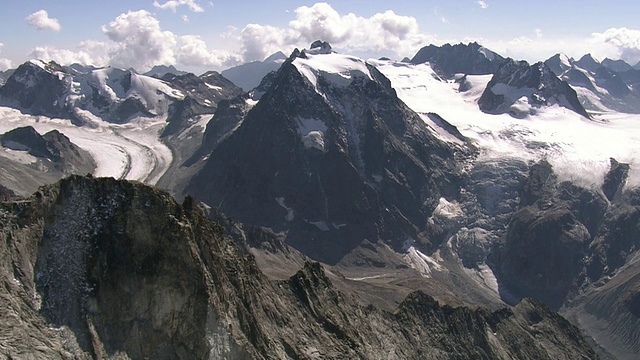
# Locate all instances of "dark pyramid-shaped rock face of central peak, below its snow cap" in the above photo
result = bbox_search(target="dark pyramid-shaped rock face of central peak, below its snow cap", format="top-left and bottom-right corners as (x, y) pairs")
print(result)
(187, 50), (459, 262)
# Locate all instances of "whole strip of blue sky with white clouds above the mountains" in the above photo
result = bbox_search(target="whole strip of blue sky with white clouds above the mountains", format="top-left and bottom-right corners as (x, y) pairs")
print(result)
(0, 0), (640, 71)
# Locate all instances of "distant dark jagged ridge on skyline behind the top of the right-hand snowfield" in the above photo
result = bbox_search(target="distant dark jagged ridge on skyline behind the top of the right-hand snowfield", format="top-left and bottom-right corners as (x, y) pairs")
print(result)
(411, 42), (505, 76)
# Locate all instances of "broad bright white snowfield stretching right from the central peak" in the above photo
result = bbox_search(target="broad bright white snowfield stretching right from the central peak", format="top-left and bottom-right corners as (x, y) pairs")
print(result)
(368, 60), (640, 186)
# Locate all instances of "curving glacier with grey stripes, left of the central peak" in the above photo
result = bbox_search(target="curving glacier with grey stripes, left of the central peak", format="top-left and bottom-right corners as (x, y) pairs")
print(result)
(0, 107), (173, 185)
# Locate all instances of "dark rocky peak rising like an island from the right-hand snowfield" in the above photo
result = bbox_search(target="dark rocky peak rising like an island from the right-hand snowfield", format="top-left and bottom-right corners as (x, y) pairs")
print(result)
(478, 59), (589, 118)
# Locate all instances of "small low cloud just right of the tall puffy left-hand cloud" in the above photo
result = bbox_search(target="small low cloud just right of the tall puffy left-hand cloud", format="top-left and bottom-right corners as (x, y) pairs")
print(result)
(176, 35), (241, 68)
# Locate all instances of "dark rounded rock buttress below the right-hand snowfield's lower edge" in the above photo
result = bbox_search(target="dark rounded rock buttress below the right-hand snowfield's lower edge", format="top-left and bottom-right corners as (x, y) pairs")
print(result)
(493, 162), (608, 308)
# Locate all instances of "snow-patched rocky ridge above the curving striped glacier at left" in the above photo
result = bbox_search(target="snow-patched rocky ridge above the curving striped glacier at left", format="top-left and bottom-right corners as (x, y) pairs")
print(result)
(0, 60), (242, 131)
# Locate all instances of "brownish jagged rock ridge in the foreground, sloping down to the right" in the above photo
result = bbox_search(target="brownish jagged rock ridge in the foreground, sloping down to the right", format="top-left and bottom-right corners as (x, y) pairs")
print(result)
(0, 176), (597, 359)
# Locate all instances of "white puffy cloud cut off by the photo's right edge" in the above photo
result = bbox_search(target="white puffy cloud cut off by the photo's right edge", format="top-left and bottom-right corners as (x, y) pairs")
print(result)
(592, 27), (640, 64)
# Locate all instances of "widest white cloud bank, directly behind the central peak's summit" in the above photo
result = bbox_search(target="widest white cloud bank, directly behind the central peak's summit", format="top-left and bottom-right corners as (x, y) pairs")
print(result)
(240, 3), (430, 61)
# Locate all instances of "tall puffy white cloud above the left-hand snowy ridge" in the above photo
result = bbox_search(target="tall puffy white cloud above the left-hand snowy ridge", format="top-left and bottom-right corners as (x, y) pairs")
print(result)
(102, 10), (177, 71)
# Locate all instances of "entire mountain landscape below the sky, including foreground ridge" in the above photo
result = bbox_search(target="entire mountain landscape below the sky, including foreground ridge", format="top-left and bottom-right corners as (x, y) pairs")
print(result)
(0, 41), (640, 359)
